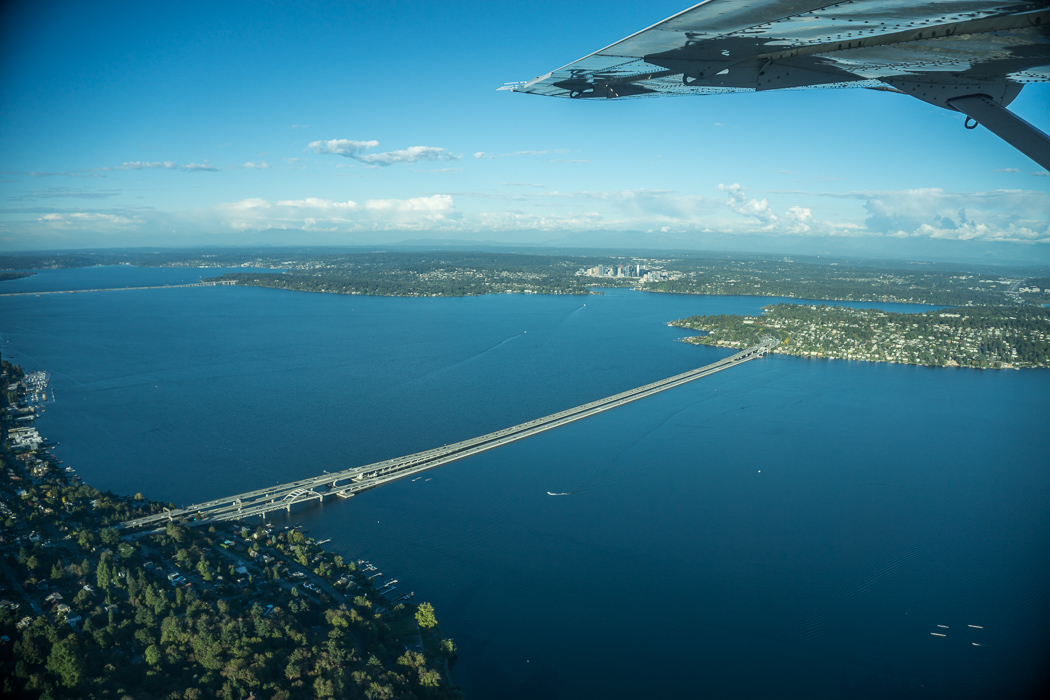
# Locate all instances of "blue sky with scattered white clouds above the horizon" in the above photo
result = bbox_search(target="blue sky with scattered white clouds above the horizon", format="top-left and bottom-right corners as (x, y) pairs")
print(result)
(0, 0), (1050, 261)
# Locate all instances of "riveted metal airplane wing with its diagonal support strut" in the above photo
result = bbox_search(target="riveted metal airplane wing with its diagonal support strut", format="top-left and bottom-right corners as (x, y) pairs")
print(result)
(500, 0), (1050, 169)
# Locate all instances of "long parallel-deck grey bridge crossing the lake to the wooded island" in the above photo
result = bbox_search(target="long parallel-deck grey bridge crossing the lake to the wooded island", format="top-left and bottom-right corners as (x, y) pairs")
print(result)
(122, 338), (777, 528)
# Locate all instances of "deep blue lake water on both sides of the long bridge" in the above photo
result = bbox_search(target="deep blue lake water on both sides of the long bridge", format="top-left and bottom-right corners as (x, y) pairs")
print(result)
(0, 268), (1050, 698)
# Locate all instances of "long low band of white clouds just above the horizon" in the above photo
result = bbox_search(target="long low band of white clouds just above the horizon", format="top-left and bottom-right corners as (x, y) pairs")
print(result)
(18, 184), (1050, 250)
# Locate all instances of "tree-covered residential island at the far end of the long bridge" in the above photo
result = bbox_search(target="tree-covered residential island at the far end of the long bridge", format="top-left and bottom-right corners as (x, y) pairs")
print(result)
(672, 303), (1050, 368)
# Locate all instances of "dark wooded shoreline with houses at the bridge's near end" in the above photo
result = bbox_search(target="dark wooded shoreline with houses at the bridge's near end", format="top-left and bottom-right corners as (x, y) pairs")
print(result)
(0, 361), (462, 700)
